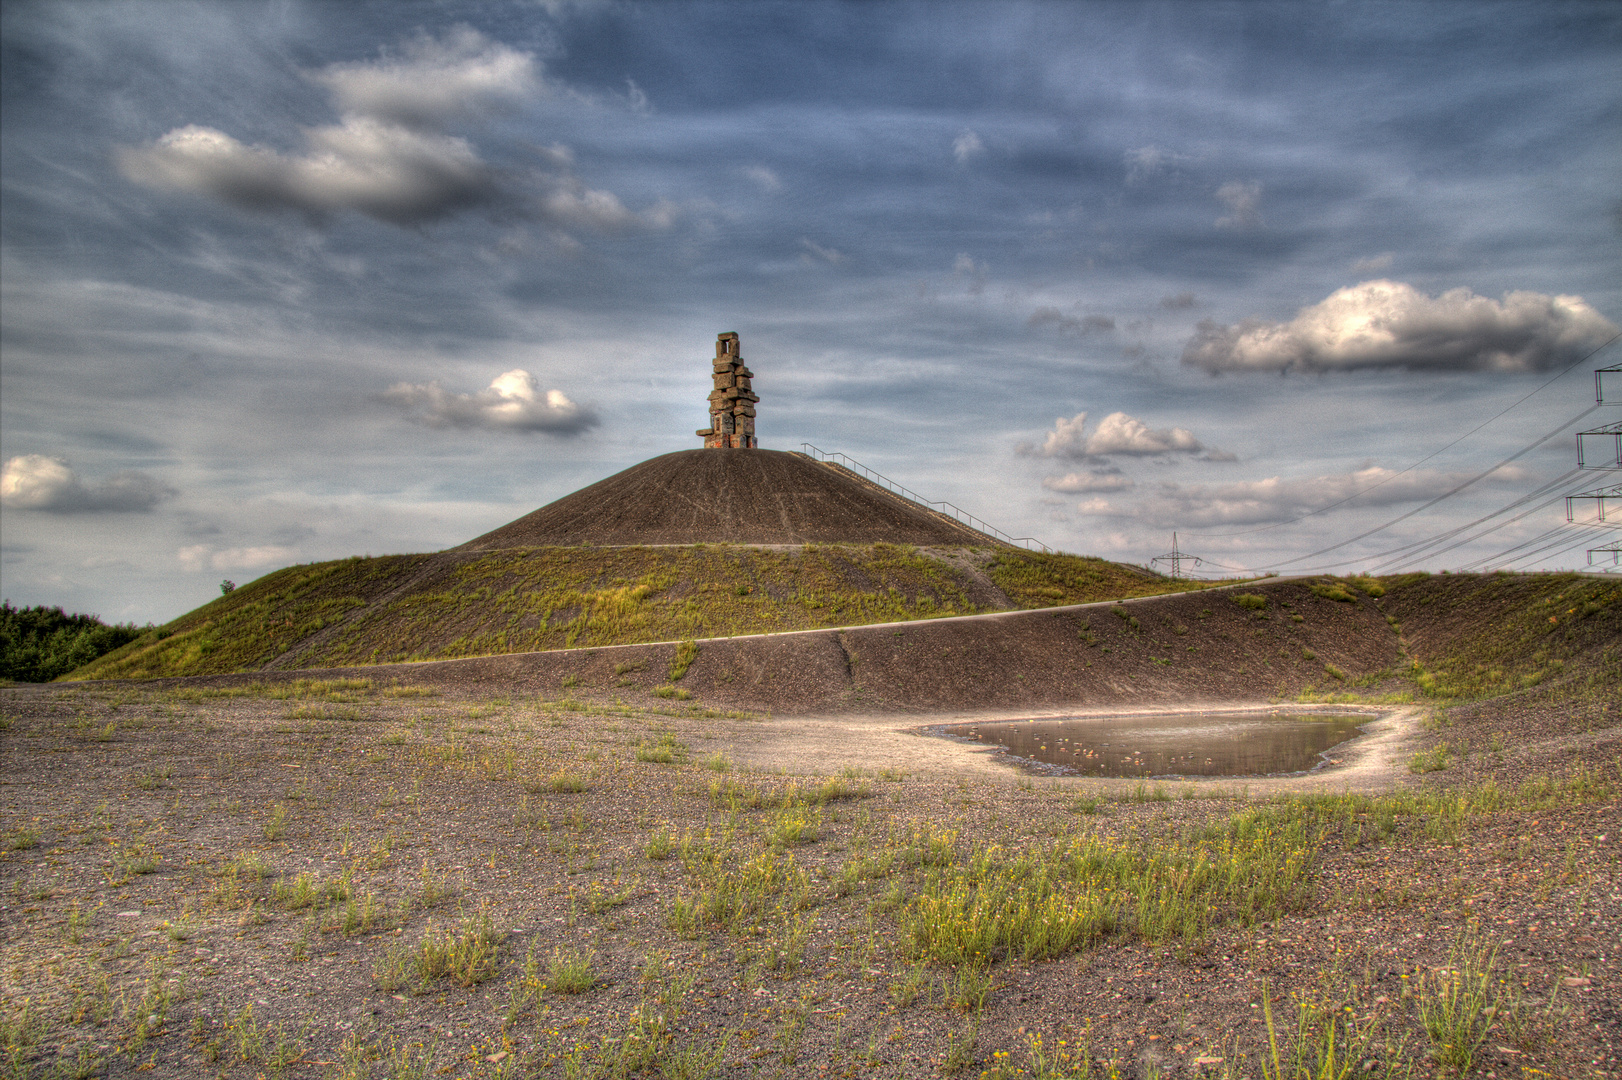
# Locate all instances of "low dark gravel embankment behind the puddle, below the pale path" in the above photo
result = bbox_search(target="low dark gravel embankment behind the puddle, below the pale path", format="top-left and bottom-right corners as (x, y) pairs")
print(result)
(75, 574), (1622, 713)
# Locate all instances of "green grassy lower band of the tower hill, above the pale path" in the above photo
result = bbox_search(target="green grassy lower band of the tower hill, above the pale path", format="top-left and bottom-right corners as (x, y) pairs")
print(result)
(70, 543), (1202, 679)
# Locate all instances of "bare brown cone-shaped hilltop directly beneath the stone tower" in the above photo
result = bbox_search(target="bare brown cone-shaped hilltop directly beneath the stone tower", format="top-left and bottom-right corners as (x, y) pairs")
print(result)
(454, 449), (998, 551)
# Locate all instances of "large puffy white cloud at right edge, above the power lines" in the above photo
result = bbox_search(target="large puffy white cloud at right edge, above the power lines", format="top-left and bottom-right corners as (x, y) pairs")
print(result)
(1182, 279), (1617, 373)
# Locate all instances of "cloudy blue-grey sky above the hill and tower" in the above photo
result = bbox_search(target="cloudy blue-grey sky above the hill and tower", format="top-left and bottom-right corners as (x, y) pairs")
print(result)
(0, 0), (1622, 623)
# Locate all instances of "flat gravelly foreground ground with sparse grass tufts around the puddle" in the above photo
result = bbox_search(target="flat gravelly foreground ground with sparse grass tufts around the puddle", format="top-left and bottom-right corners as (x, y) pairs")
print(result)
(0, 664), (1622, 1078)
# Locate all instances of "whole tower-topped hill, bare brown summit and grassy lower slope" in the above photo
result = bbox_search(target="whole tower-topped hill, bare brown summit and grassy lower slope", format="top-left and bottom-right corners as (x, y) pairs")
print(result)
(75, 449), (1239, 678)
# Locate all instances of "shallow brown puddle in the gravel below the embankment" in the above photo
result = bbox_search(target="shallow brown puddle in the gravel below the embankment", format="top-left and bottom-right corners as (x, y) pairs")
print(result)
(929, 712), (1374, 777)
